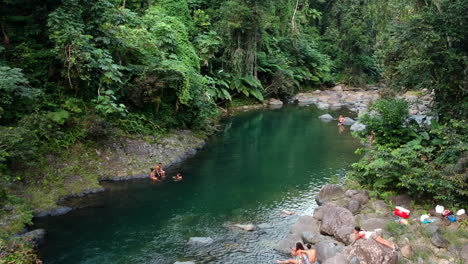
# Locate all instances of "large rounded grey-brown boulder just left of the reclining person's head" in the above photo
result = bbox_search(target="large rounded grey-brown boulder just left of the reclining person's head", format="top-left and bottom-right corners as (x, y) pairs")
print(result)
(320, 205), (356, 245)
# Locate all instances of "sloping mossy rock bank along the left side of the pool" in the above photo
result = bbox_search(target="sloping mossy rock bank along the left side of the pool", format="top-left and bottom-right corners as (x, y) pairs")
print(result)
(0, 130), (206, 254)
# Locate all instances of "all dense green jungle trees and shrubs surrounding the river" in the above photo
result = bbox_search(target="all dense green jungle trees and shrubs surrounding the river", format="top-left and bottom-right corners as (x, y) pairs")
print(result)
(0, 0), (468, 262)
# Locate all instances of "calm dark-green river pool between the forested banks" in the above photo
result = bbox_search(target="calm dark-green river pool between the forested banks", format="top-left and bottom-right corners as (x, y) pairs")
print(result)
(35, 107), (359, 264)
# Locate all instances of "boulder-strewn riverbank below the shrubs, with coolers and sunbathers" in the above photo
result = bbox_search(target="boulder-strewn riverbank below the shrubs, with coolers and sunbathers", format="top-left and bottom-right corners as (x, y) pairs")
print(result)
(275, 184), (468, 264)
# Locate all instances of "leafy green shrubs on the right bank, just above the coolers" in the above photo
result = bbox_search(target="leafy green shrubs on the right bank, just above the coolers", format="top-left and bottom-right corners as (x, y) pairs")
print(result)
(349, 99), (468, 208)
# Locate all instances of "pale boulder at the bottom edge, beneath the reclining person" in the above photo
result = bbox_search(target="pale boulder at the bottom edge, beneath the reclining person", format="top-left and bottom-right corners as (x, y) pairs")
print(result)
(344, 239), (398, 264)
